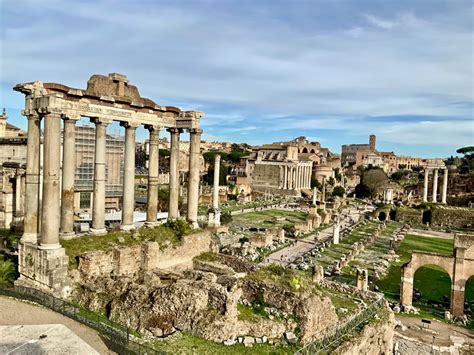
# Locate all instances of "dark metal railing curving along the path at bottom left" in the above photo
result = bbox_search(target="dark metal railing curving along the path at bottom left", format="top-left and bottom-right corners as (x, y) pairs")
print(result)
(0, 286), (166, 355)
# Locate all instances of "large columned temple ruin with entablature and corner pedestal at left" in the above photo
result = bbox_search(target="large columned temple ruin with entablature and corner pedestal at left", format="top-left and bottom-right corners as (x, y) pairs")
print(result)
(14, 73), (202, 295)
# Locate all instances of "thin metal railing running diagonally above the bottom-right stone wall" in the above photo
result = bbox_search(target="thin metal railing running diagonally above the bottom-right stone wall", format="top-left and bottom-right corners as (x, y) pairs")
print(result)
(295, 297), (385, 355)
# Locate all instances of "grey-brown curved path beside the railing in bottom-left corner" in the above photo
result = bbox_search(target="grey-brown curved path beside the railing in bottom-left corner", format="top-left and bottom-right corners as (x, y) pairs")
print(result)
(0, 296), (114, 354)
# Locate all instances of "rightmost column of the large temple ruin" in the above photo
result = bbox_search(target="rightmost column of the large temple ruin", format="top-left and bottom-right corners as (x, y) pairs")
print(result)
(188, 128), (202, 228)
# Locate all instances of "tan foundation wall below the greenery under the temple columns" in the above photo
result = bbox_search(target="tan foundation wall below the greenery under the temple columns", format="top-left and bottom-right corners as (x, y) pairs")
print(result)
(78, 231), (211, 278)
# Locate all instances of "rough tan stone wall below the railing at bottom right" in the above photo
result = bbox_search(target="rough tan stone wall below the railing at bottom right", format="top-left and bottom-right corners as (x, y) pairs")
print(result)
(332, 310), (395, 355)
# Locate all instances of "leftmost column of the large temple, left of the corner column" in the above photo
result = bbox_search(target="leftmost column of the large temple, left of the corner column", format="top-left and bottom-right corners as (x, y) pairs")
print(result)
(21, 112), (41, 244)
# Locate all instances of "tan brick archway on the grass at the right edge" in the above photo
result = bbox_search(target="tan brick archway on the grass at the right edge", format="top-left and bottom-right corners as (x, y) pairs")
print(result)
(400, 235), (474, 316)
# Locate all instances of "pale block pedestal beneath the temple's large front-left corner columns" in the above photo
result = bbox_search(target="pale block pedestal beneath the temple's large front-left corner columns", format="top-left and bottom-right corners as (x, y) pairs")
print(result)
(15, 243), (72, 297)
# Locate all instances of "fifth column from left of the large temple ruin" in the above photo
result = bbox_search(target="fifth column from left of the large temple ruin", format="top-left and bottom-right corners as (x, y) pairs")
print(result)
(120, 122), (138, 230)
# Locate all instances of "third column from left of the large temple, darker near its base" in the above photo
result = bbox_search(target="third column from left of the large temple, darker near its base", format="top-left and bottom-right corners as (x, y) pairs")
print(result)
(59, 117), (76, 239)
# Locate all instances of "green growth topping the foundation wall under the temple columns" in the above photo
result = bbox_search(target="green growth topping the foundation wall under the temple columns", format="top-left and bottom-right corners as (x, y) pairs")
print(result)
(60, 225), (189, 267)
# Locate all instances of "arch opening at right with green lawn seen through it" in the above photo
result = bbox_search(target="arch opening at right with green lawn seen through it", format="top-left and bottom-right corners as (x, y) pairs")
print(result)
(413, 264), (451, 317)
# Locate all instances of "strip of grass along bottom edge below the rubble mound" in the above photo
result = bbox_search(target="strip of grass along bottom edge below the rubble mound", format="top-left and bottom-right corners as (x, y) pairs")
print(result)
(153, 333), (298, 355)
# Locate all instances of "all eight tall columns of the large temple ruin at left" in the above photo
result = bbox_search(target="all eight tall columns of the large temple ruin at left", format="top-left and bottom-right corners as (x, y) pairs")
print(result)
(22, 112), (202, 249)
